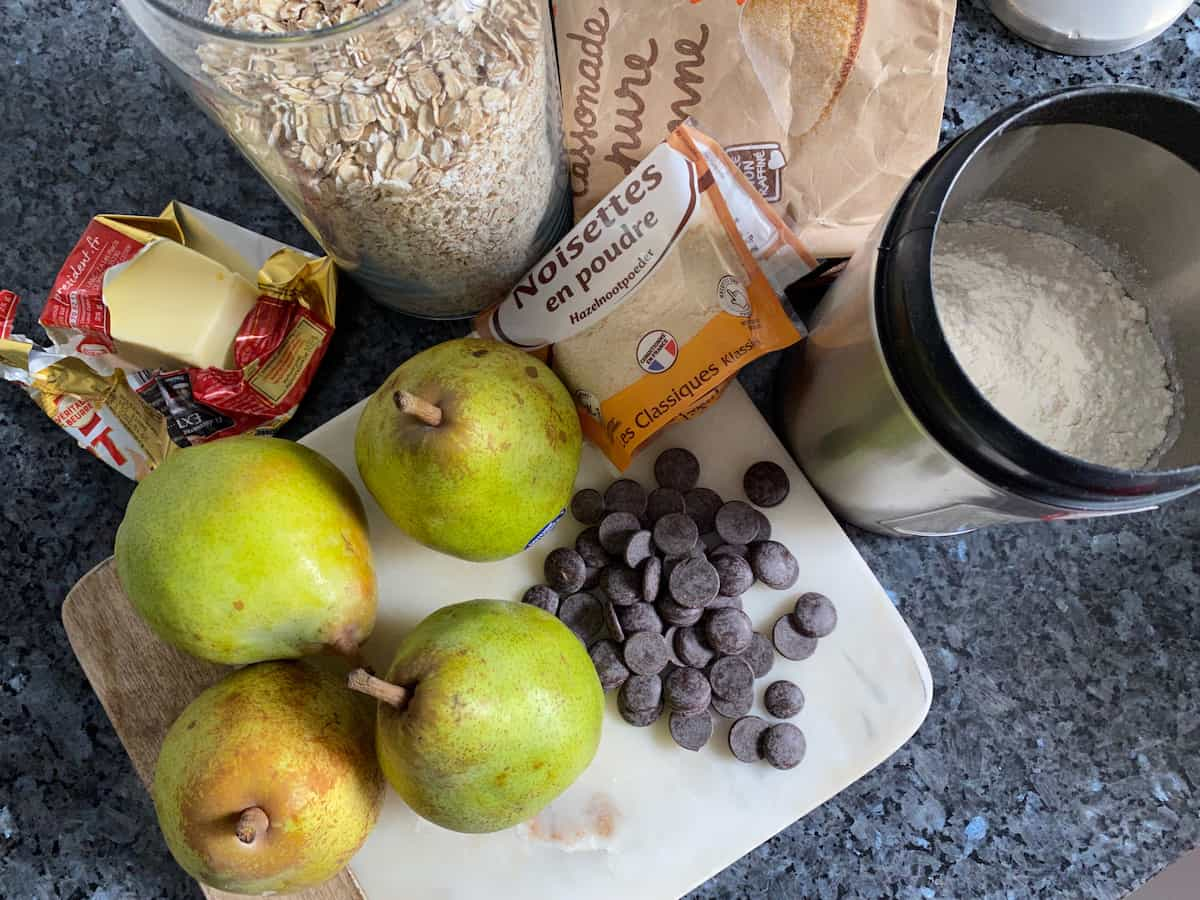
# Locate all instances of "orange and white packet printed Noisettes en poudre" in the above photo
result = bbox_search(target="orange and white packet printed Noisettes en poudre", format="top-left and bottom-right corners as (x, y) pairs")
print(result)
(475, 122), (816, 469)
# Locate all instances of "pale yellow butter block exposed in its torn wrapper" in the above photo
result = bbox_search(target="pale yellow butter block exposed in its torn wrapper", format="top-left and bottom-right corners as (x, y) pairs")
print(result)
(103, 239), (259, 370)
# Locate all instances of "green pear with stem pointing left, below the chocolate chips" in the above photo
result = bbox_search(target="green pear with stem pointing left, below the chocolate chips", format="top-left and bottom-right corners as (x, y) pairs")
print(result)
(350, 600), (604, 833)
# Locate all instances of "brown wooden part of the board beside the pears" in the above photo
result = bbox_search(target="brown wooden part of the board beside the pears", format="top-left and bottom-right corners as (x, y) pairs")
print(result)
(62, 558), (366, 900)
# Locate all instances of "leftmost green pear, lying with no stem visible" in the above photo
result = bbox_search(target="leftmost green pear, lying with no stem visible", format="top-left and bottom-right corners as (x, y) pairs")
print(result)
(115, 437), (376, 665)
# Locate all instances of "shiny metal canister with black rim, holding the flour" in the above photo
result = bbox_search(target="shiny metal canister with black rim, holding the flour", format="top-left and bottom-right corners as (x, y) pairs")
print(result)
(781, 86), (1200, 534)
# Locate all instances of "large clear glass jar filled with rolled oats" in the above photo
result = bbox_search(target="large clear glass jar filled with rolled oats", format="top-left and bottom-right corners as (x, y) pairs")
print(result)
(121, 0), (569, 318)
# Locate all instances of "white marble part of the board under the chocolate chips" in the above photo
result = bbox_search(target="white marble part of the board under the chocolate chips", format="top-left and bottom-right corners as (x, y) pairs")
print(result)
(302, 383), (932, 900)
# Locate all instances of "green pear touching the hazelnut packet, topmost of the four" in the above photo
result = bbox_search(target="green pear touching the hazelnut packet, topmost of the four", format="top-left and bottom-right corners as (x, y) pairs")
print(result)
(355, 338), (582, 562)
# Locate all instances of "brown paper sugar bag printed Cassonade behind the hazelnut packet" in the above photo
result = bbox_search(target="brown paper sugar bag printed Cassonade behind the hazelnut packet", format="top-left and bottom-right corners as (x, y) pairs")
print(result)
(556, 0), (954, 257)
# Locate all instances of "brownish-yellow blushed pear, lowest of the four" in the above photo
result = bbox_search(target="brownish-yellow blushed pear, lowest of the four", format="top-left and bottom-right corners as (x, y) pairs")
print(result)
(154, 661), (384, 894)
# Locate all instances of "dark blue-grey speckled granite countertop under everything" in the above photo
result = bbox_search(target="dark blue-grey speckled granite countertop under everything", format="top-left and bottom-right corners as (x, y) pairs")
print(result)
(0, 0), (1200, 900)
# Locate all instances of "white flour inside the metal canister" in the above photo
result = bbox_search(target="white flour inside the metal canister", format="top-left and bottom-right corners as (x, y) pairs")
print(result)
(934, 222), (1174, 469)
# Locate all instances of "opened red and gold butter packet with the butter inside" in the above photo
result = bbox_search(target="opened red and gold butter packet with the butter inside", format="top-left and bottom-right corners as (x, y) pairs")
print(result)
(0, 203), (337, 480)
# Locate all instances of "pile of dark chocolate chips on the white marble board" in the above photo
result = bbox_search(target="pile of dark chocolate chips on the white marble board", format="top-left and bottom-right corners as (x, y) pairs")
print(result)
(523, 448), (836, 769)
